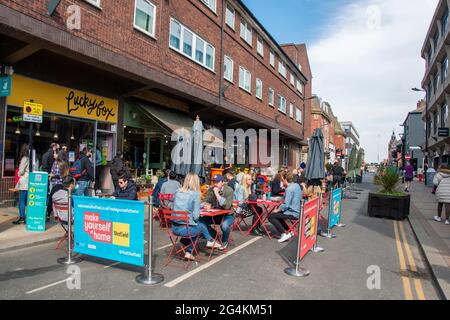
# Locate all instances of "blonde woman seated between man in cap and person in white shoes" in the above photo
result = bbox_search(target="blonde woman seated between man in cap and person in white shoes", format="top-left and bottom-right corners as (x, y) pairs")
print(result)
(234, 174), (264, 237)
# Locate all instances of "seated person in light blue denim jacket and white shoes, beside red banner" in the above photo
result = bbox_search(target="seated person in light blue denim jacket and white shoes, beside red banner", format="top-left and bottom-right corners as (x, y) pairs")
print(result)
(269, 173), (302, 243)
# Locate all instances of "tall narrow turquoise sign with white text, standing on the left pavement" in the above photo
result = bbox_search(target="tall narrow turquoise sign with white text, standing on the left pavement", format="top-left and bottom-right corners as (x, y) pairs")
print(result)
(26, 172), (48, 232)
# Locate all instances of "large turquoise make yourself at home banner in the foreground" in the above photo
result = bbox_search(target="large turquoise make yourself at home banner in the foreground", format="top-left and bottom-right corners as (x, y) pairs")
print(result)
(73, 196), (144, 267)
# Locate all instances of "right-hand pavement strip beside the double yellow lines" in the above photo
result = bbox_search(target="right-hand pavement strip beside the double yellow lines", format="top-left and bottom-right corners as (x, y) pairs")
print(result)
(409, 181), (450, 300)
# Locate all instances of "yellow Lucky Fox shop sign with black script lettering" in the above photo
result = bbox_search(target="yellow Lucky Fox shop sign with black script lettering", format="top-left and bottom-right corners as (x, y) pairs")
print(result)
(8, 74), (119, 123)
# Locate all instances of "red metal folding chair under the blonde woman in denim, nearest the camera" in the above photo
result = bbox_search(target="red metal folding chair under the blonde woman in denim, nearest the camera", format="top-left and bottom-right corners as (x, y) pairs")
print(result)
(163, 210), (200, 269)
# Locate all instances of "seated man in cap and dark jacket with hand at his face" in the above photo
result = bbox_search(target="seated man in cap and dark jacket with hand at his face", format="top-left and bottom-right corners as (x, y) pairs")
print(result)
(200, 175), (235, 250)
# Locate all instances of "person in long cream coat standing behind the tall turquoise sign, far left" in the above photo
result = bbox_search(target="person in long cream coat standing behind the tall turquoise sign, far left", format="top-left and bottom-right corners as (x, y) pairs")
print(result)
(13, 143), (30, 224)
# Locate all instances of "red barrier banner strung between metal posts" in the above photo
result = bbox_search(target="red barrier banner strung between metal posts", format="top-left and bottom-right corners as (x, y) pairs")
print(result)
(300, 198), (319, 260)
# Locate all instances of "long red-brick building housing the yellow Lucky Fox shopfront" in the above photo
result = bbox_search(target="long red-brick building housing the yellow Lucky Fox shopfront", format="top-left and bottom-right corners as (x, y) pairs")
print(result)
(0, 0), (307, 204)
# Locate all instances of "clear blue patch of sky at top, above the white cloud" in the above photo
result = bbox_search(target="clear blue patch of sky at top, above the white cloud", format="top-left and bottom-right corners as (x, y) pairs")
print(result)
(244, 0), (356, 44)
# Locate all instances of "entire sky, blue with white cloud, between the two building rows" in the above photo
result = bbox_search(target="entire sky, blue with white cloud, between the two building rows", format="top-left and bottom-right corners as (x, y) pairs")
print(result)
(243, 0), (439, 162)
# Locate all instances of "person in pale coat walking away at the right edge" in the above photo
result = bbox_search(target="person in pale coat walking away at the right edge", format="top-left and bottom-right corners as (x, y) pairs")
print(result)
(433, 164), (450, 225)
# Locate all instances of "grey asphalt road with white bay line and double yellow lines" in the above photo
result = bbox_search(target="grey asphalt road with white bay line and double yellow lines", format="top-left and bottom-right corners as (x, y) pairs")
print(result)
(0, 177), (442, 301)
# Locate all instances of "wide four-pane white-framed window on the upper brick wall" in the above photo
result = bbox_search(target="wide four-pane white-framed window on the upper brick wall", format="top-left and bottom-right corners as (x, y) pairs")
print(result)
(169, 18), (215, 71)
